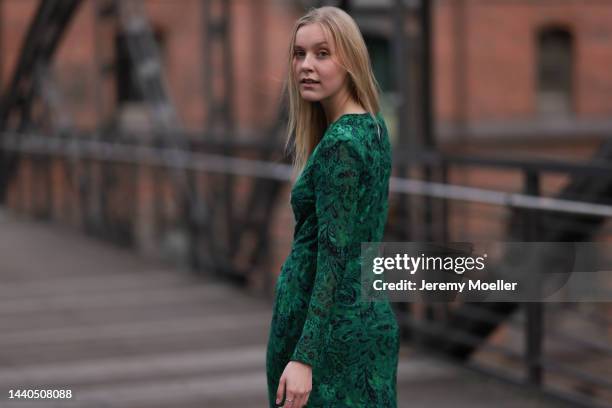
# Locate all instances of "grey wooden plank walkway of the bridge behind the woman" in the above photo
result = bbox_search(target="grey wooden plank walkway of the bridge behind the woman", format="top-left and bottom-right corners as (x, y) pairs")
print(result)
(0, 211), (564, 408)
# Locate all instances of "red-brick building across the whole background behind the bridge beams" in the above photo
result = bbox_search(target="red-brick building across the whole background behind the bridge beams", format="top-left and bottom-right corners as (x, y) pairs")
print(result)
(0, 0), (612, 278)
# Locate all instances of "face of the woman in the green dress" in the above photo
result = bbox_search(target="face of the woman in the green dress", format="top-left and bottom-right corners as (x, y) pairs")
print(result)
(293, 24), (347, 104)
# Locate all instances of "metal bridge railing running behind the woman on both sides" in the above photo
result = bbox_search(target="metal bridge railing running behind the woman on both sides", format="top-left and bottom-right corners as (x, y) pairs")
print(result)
(1, 133), (612, 406)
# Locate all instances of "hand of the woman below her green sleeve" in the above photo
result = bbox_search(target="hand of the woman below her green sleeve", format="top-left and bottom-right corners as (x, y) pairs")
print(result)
(276, 361), (312, 408)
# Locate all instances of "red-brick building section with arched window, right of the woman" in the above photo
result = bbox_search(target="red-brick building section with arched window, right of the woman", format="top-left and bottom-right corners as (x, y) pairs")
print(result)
(436, 0), (612, 147)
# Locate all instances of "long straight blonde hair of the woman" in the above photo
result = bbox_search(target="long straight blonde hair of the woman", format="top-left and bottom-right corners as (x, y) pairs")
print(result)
(285, 6), (380, 178)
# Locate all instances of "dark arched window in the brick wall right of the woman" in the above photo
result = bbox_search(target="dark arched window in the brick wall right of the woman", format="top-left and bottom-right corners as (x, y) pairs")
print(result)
(537, 27), (574, 115)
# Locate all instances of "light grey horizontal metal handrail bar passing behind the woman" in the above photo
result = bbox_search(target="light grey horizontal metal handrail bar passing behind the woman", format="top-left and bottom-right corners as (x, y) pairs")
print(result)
(1, 135), (612, 217)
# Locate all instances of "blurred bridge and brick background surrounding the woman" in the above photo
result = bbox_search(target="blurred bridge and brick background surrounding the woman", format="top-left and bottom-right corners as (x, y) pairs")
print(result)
(0, 0), (612, 408)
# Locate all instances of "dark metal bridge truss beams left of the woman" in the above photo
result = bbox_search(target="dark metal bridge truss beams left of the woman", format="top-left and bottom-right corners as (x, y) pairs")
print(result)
(0, 0), (286, 283)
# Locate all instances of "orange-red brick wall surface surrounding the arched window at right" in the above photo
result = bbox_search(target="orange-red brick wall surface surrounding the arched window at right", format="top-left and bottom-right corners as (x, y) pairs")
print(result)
(435, 0), (612, 121)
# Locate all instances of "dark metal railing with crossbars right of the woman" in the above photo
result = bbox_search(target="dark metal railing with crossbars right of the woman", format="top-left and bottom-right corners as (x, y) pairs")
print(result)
(392, 142), (612, 407)
